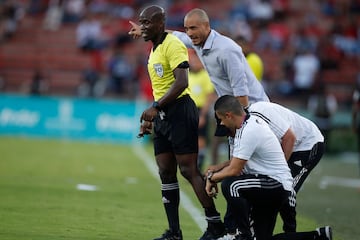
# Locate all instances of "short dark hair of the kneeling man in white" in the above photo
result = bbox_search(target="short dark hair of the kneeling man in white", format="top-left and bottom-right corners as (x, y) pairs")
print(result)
(214, 95), (244, 116)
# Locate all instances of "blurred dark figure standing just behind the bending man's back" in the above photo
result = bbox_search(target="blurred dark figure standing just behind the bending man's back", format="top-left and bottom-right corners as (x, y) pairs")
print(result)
(308, 81), (338, 151)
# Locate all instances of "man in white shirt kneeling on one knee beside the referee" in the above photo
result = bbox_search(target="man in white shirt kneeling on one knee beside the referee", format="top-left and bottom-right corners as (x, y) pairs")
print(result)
(206, 95), (332, 240)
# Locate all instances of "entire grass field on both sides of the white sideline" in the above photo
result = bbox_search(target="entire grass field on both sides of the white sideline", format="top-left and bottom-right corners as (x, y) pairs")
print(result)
(0, 137), (360, 240)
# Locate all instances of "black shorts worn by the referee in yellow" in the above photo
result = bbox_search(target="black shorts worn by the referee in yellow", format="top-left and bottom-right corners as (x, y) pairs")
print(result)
(154, 95), (199, 156)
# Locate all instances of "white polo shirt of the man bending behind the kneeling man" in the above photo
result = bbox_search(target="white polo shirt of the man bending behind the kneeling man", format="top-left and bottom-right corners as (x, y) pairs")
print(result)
(248, 102), (324, 152)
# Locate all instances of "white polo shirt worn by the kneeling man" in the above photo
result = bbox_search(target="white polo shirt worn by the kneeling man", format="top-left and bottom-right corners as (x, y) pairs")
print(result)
(229, 115), (293, 191)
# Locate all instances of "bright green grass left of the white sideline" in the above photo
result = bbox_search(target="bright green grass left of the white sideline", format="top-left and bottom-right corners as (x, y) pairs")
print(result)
(0, 138), (201, 240)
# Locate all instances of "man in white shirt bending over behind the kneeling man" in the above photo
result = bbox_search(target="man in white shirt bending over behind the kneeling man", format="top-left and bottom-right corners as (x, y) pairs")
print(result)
(248, 102), (324, 232)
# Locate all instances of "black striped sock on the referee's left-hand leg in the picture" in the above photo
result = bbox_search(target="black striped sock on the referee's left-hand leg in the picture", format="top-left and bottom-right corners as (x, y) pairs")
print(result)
(161, 182), (180, 232)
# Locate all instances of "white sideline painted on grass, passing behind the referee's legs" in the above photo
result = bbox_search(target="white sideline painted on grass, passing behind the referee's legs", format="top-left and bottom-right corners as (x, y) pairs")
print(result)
(133, 143), (207, 231)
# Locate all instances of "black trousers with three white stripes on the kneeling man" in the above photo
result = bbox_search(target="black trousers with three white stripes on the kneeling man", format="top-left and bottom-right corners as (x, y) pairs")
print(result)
(221, 174), (290, 240)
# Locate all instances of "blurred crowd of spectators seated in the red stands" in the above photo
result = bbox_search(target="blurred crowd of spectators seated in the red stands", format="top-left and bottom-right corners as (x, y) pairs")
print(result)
(0, 0), (360, 106)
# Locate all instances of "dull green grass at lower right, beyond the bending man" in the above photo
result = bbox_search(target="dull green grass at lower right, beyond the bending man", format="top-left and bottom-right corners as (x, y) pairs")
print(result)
(297, 154), (360, 240)
